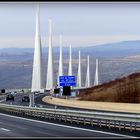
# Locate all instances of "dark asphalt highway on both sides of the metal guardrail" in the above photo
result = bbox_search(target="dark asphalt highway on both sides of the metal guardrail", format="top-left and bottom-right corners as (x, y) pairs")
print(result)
(0, 94), (140, 138)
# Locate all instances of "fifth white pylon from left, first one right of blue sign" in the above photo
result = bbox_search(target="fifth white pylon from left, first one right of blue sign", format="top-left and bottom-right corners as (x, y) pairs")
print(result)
(77, 51), (81, 87)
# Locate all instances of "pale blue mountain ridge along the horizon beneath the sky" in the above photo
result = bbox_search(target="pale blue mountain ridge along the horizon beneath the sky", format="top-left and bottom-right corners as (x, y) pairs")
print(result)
(0, 40), (140, 57)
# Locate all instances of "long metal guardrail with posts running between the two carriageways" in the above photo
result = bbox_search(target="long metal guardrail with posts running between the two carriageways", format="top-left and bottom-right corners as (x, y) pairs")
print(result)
(0, 104), (140, 132)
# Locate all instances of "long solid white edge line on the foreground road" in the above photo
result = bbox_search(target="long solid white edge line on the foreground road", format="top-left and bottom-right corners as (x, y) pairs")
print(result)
(0, 113), (137, 138)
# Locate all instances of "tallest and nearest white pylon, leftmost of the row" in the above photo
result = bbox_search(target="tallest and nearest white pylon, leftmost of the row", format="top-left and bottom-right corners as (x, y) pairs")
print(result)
(31, 4), (42, 92)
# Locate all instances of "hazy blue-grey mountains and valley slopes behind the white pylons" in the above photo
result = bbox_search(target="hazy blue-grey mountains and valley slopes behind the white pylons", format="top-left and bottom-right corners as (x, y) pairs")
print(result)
(0, 41), (140, 88)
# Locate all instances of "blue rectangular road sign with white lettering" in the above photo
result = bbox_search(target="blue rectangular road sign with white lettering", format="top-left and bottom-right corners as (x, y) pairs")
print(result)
(59, 76), (76, 86)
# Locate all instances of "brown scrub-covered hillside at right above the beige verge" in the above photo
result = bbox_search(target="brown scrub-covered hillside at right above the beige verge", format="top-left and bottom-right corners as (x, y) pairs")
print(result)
(79, 73), (140, 103)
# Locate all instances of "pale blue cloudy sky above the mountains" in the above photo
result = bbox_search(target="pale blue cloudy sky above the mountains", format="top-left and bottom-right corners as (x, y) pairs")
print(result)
(0, 2), (140, 48)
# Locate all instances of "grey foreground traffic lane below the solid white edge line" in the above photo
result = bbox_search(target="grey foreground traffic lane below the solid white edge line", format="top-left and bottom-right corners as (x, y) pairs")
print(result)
(0, 113), (125, 138)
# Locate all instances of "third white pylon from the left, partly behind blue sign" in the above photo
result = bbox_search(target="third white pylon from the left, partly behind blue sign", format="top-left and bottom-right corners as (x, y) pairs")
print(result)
(57, 35), (63, 84)
